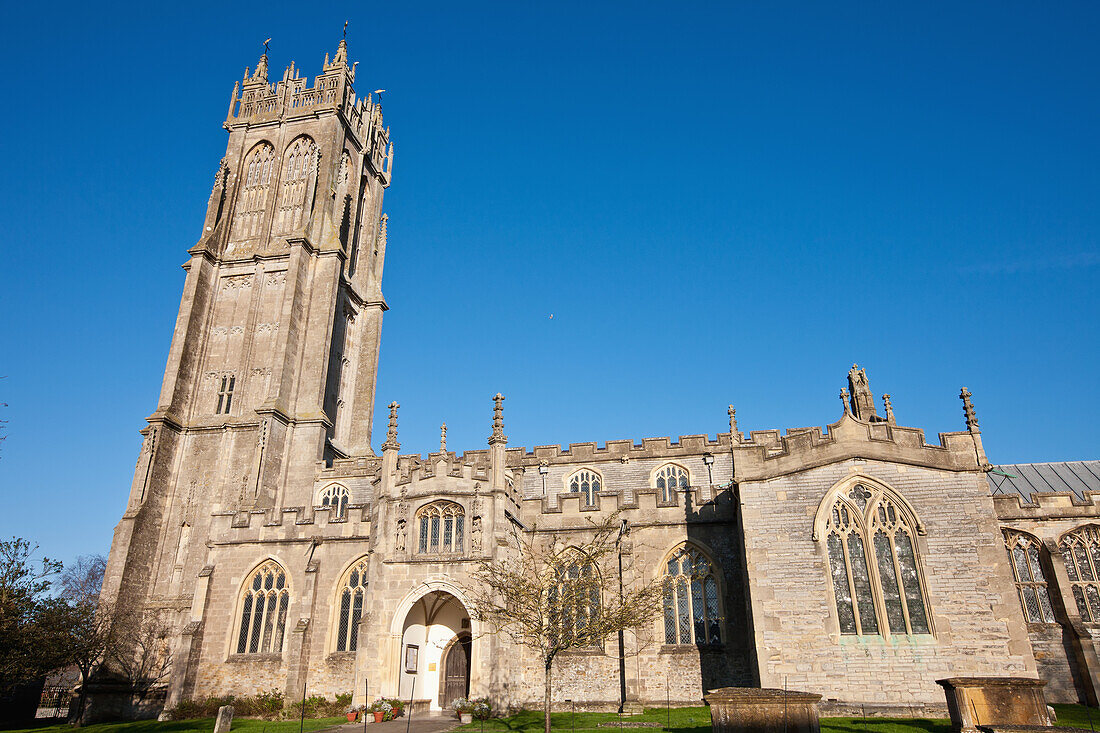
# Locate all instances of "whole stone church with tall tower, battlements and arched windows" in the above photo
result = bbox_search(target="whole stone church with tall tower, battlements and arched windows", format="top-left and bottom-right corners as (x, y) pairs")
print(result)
(103, 37), (1100, 710)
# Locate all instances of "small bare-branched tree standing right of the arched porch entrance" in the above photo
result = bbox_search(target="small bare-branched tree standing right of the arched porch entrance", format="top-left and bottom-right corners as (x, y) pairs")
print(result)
(465, 512), (666, 733)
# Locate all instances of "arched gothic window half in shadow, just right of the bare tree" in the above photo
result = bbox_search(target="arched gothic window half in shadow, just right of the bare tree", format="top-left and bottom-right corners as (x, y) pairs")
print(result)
(664, 545), (722, 645)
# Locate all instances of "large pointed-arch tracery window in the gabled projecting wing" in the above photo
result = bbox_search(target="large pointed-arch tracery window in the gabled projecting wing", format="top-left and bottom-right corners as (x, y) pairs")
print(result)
(824, 483), (931, 635)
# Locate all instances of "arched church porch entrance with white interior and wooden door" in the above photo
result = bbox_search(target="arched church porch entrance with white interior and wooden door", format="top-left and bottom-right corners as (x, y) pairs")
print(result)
(398, 590), (473, 710)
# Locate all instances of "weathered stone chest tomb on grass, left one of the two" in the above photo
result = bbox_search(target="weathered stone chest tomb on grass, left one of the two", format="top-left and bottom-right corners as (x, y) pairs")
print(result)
(703, 687), (822, 733)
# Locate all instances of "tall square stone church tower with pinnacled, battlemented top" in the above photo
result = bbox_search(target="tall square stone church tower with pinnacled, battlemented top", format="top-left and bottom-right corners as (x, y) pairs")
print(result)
(105, 41), (393, 603)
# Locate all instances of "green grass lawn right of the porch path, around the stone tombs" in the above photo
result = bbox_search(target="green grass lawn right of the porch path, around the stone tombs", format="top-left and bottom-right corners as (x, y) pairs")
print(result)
(458, 705), (1100, 733)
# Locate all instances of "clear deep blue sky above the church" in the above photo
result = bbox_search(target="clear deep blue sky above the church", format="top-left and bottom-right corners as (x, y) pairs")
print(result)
(0, 2), (1100, 560)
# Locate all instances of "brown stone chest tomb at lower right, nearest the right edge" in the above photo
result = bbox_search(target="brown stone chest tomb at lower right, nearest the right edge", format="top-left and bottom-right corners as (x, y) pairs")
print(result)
(936, 677), (1051, 733)
